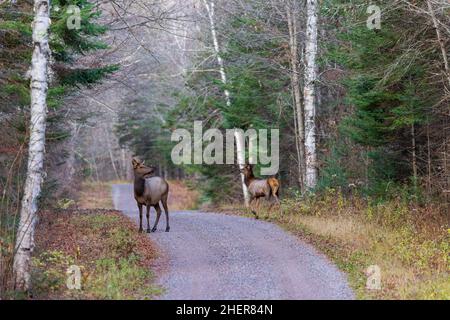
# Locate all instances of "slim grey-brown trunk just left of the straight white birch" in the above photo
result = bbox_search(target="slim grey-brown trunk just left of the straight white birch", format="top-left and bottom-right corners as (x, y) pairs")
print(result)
(286, 5), (305, 193)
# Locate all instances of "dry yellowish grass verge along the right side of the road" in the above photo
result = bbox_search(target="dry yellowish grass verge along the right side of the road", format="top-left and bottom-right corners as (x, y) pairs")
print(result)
(216, 192), (450, 300)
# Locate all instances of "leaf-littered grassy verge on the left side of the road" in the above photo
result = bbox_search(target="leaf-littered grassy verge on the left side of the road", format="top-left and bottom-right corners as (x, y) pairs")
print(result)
(32, 209), (162, 299)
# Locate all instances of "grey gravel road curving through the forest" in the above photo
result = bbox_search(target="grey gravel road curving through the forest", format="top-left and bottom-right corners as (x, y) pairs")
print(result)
(112, 184), (354, 300)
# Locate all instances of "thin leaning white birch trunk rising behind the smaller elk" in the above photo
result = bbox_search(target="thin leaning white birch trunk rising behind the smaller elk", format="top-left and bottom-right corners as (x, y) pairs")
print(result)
(203, 0), (250, 207)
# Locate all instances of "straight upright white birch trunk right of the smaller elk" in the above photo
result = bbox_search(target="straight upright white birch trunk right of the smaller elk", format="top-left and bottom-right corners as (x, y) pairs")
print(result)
(303, 0), (318, 189)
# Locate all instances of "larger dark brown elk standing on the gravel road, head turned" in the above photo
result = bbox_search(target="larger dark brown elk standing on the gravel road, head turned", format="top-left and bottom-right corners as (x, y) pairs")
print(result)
(131, 158), (170, 232)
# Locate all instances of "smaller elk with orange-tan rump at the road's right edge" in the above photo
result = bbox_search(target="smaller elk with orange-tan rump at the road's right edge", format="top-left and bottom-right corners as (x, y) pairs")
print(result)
(240, 164), (280, 219)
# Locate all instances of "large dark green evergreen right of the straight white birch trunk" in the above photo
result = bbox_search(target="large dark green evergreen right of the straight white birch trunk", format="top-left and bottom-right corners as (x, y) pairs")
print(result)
(321, 0), (440, 198)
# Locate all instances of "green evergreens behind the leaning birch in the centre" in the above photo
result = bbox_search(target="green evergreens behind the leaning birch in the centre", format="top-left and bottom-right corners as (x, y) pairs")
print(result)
(142, 12), (292, 203)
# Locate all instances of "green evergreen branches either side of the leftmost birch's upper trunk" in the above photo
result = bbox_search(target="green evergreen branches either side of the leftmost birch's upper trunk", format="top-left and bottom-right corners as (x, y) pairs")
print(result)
(0, 0), (114, 113)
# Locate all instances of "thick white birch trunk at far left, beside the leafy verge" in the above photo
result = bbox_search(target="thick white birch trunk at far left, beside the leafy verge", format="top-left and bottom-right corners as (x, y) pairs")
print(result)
(14, 0), (50, 291)
